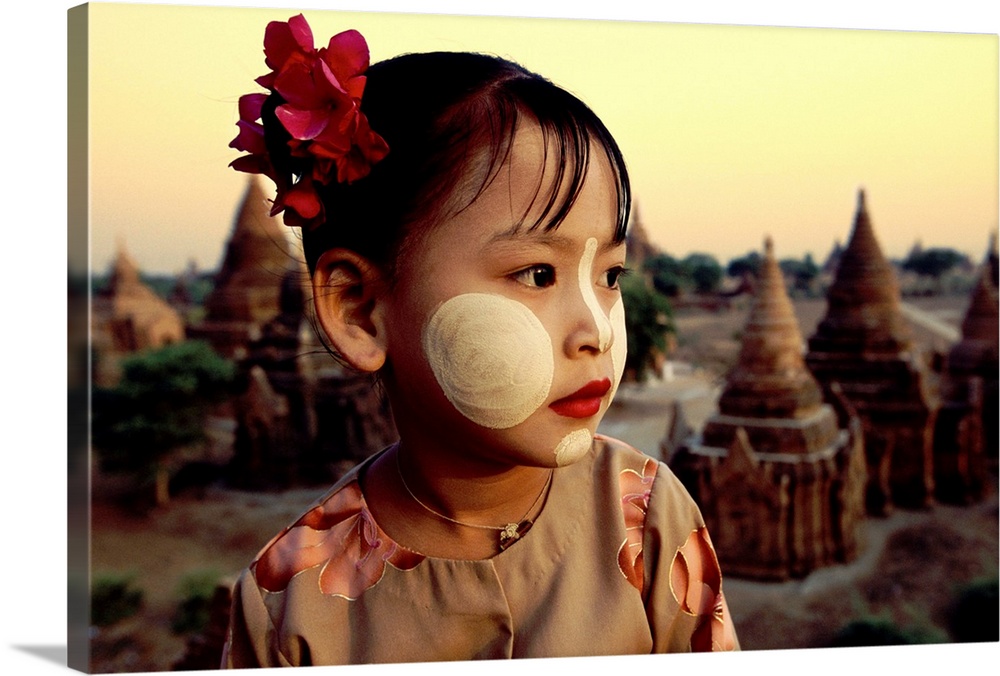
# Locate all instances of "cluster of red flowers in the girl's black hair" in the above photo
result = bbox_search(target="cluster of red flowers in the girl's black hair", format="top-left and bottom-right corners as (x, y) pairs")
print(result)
(230, 14), (389, 227)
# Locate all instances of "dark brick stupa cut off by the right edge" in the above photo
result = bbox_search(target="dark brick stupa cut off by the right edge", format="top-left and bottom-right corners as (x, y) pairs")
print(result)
(934, 244), (1000, 504)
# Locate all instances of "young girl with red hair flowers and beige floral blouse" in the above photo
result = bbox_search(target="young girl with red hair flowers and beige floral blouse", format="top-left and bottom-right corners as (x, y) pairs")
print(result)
(223, 16), (737, 667)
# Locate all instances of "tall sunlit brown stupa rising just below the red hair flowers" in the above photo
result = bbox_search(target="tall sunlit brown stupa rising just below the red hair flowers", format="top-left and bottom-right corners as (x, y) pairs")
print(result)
(190, 175), (296, 359)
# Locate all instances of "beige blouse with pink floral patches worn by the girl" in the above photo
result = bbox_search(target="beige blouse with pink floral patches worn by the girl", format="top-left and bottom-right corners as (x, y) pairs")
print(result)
(222, 435), (738, 668)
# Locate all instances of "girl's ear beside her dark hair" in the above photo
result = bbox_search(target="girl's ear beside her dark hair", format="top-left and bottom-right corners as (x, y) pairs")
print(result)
(313, 249), (386, 372)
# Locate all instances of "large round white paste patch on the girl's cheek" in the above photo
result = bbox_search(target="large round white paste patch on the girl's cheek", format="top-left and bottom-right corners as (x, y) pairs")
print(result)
(423, 293), (555, 429)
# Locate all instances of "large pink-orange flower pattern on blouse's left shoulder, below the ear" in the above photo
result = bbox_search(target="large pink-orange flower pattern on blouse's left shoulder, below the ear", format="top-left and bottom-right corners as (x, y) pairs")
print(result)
(251, 481), (424, 601)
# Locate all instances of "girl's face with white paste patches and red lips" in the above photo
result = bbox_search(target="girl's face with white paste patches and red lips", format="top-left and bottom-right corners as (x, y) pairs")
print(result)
(383, 125), (626, 467)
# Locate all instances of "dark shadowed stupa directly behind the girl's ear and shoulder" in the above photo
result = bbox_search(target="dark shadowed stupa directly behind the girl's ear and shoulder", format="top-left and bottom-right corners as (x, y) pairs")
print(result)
(230, 259), (398, 488)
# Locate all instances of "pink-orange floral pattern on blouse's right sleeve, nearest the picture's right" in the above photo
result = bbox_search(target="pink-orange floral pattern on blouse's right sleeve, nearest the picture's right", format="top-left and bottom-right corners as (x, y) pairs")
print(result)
(670, 526), (736, 652)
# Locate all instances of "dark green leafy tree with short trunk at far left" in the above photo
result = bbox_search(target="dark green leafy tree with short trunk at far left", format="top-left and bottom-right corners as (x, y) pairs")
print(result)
(92, 341), (235, 504)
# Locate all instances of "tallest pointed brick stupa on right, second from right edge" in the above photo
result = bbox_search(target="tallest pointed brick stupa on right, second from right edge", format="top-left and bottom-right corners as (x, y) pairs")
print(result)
(806, 190), (936, 515)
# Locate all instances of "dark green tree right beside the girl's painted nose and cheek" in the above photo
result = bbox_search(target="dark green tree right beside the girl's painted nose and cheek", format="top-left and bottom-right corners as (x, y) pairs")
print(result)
(621, 275), (674, 381)
